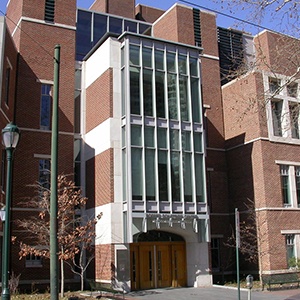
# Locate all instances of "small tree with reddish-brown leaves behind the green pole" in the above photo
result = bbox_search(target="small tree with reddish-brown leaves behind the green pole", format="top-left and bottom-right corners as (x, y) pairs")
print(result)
(16, 175), (101, 296)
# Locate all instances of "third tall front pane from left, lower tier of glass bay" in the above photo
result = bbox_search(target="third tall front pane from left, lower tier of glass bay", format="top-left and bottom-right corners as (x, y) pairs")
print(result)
(158, 151), (168, 201)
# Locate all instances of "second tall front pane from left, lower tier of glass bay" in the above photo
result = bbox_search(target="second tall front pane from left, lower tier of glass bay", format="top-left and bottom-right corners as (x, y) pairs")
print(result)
(145, 149), (155, 200)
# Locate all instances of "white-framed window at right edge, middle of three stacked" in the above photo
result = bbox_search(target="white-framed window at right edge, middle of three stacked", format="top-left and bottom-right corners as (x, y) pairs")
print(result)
(280, 165), (300, 207)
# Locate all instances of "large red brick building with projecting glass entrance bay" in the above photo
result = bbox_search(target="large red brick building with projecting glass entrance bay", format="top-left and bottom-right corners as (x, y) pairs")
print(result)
(0, 0), (300, 290)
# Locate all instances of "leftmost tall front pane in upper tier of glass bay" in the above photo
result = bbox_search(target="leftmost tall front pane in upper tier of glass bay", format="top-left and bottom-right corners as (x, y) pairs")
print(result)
(130, 67), (141, 115)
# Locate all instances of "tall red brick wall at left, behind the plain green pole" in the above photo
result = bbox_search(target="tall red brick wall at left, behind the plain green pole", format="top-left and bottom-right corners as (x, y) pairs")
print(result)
(8, 0), (76, 281)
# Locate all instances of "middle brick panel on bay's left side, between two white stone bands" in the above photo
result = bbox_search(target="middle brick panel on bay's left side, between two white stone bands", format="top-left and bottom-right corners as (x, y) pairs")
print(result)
(86, 149), (114, 208)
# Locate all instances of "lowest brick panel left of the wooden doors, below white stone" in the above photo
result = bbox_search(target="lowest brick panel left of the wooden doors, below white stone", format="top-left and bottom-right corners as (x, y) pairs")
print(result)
(95, 244), (115, 280)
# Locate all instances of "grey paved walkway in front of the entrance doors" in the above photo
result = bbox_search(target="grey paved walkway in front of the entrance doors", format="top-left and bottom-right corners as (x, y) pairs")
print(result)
(125, 285), (300, 300)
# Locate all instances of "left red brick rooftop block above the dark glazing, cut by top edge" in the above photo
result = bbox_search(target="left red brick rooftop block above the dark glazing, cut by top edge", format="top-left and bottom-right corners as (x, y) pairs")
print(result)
(90, 0), (135, 19)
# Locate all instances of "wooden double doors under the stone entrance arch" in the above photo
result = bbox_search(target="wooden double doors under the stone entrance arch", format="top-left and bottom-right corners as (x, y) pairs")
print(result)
(130, 242), (186, 290)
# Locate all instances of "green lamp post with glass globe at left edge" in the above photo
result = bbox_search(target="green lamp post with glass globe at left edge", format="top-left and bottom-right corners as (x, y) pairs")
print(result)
(1, 123), (20, 300)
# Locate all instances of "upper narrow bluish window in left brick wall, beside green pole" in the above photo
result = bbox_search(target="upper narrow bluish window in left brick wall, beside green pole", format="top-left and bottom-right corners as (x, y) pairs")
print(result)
(40, 84), (52, 130)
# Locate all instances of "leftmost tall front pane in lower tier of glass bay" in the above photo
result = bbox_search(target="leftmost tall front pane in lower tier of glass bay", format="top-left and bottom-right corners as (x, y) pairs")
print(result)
(131, 148), (143, 200)
